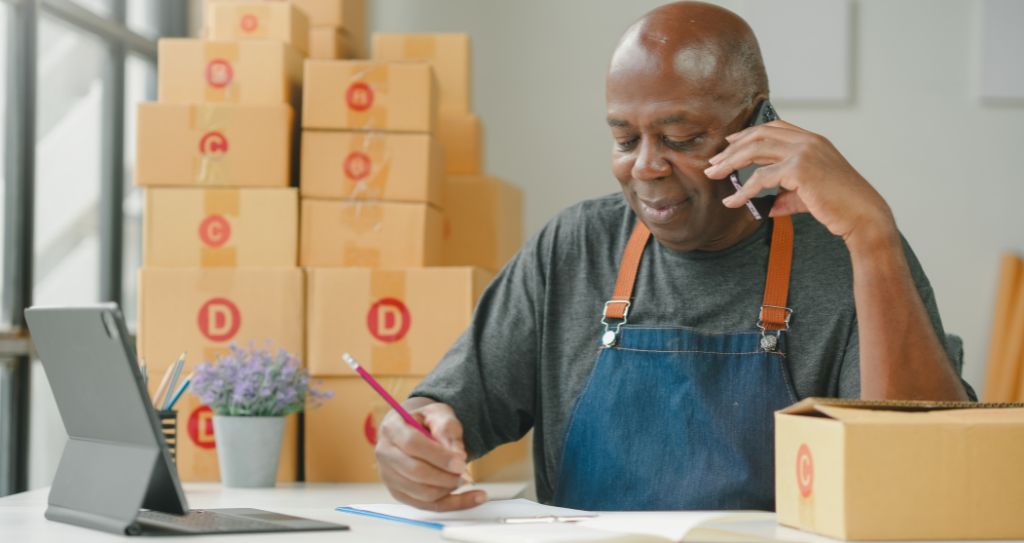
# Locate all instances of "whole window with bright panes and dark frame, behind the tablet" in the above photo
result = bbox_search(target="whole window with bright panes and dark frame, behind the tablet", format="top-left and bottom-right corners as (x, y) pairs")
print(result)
(0, 0), (187, 496)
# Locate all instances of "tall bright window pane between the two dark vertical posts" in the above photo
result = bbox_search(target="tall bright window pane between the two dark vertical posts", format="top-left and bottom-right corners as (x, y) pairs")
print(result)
(33, 14), (110, 305)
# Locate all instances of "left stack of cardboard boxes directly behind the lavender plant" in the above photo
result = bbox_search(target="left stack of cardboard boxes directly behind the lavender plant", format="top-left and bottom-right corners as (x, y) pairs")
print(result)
(135, 2), (308, 481)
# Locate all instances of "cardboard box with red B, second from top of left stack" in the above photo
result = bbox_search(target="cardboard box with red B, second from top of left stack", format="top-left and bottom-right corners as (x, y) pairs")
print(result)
(158, 38), (302, 103)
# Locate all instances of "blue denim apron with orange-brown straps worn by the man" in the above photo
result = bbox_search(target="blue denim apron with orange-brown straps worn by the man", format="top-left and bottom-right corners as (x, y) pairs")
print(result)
(554, 217), (798, 510)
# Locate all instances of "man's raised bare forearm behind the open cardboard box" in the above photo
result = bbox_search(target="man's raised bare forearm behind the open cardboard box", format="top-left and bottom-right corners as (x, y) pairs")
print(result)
(847, 222), (968, 400)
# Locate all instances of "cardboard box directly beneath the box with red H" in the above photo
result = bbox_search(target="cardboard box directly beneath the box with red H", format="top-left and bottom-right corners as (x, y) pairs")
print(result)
(299, 130), (443, 207)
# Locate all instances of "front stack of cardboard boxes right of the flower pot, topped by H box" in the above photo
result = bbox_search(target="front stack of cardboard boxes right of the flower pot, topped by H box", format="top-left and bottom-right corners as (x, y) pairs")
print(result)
(300, 39), (528, 482)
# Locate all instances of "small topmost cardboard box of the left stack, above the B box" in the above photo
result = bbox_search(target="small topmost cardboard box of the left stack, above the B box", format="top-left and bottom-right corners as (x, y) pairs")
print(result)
(206, 0), (309, 54)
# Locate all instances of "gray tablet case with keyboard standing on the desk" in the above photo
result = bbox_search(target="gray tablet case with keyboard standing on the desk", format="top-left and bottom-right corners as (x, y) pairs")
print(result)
(25, 304), (347, 535)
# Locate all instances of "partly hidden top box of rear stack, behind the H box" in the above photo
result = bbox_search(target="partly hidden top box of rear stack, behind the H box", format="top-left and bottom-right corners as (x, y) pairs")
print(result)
(371, 32), (473, 114)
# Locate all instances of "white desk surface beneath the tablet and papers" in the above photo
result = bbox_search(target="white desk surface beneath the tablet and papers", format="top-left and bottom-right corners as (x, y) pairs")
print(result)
(0, 483), (1019, 543)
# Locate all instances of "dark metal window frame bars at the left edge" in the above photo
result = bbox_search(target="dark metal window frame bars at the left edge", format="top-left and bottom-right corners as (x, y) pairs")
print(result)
(0, 0), (189, 496)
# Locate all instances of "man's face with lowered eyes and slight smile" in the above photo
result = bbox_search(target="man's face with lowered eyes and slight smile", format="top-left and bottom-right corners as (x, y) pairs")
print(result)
(606, 50), (755, 251)
